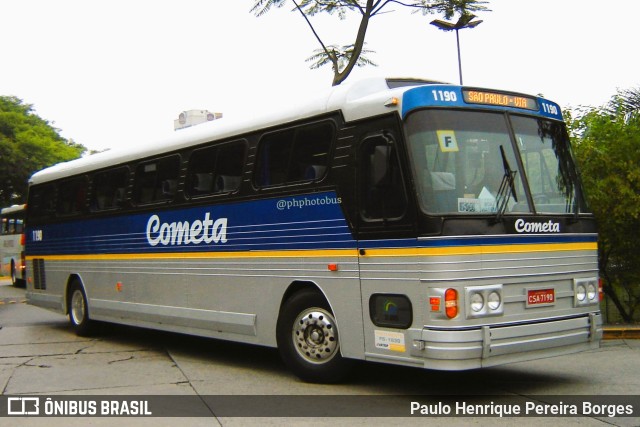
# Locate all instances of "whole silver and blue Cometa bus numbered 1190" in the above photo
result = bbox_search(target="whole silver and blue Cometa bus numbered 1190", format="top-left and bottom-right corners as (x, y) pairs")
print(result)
(26, 79), (602, 382)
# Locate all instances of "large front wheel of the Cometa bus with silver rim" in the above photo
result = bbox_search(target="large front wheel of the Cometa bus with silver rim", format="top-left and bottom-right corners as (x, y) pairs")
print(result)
(276, 289), (352, 383)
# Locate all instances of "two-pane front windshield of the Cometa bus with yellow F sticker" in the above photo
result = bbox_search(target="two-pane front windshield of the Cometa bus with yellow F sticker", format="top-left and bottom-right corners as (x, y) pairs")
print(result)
(407, 110), (588, 214)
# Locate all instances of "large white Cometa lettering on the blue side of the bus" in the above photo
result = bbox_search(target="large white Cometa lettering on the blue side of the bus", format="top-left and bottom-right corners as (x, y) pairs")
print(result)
(147, 212), (227, 246)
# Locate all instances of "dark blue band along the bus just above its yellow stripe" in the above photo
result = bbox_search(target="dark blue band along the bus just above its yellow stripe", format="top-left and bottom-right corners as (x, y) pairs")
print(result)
(26, 192), (596, 257)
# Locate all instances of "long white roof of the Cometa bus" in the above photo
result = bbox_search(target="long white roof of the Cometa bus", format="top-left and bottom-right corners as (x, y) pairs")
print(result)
(29, 77), (548, 184)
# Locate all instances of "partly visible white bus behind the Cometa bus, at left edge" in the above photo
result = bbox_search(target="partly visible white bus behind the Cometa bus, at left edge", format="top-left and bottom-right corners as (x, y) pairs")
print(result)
(0, 205), (26, 286)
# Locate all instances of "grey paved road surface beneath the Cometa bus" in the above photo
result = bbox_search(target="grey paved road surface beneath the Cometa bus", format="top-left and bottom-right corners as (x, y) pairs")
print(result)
(0, 281), (640, 427)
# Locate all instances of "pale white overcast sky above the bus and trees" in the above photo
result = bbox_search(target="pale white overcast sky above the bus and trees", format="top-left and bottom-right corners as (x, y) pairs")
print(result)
(0, 0), (640, 154)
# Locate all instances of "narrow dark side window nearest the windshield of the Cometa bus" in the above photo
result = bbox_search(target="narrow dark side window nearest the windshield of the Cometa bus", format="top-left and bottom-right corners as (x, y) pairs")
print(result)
(360, 135), (407, 220)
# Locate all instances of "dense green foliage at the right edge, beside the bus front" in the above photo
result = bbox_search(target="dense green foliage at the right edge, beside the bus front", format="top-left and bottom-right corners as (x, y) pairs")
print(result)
(568, 89), (640, 321)
